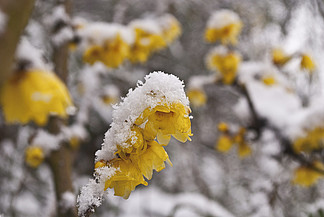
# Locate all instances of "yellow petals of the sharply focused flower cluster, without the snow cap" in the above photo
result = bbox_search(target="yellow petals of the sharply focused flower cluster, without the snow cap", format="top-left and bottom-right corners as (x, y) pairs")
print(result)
(95, 102), (192, 199)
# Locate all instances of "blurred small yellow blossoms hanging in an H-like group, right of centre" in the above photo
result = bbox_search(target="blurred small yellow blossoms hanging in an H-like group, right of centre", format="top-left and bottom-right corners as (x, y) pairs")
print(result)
(215, 122), (252, 158)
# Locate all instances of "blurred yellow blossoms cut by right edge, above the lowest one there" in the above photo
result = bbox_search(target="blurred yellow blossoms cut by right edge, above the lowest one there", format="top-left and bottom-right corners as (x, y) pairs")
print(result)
(293, 127), (324, 153)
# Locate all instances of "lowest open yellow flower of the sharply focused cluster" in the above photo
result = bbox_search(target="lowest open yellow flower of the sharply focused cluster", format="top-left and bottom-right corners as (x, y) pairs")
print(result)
(105, 158), (147, 199)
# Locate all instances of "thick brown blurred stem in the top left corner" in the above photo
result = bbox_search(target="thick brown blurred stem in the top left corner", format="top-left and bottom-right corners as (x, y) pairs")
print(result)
(0, 0), (35, 86)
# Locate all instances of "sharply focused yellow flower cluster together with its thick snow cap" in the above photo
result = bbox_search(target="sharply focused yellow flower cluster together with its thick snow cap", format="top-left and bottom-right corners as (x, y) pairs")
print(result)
(79, 72), (192, 207)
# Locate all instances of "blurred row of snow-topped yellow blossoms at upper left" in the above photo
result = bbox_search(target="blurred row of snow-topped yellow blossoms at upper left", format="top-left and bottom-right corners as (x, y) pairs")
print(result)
(83, 14), (181, 68)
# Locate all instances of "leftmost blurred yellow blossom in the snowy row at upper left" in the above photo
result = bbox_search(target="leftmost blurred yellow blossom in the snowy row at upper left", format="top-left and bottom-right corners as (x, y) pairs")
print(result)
(83, 34), (130, 68)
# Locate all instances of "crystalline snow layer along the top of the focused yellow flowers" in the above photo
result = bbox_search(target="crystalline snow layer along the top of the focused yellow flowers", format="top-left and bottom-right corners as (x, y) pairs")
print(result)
(96, 71), (189, 161)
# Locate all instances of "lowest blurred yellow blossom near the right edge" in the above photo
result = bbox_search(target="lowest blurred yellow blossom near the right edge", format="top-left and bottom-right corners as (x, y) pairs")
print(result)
(292, 161), (324, 187)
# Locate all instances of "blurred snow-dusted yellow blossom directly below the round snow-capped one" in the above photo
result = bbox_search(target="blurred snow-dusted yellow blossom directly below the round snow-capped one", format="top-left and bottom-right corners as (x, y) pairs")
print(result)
(207, 51), (241, 84)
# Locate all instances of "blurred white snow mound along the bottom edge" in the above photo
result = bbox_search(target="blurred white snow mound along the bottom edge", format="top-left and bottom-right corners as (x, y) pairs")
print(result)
(108, 186), (234, 217)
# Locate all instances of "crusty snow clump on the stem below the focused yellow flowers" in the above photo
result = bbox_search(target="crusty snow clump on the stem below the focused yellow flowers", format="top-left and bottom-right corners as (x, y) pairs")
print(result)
(77, 167), (116, 216)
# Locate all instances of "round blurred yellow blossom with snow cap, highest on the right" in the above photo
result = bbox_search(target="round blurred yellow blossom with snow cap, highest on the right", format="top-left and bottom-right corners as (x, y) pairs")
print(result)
(205, 10), (242, 45)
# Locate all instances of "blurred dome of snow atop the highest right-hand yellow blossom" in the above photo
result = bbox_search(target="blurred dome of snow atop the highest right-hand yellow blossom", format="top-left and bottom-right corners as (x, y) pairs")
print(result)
(207, 9), (241, 29)
